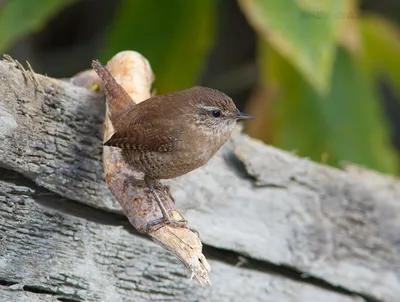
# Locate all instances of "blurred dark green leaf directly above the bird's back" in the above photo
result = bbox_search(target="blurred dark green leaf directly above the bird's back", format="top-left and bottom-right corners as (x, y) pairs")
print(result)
(101, 0), (215, 93)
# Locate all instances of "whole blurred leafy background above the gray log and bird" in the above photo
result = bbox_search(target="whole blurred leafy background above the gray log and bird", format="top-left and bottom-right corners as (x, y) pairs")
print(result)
(0, 0), (400, 175)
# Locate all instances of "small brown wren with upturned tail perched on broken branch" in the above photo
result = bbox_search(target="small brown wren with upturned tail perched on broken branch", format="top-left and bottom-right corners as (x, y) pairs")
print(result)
(92, 61), (254, 232)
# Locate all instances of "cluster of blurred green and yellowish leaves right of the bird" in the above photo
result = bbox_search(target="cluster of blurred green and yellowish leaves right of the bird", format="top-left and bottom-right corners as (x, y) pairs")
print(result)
(240, 0), (400, 174)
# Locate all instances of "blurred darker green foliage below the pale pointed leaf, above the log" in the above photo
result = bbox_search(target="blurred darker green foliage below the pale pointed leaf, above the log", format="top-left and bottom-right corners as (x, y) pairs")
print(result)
(260, 45), (398, 174)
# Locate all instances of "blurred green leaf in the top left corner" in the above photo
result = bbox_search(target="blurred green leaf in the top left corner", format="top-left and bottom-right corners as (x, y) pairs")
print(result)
(0, 0), (74, 53)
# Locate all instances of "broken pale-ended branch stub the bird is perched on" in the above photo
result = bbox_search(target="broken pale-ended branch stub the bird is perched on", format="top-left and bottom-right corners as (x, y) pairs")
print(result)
(86, 51), (211, 285)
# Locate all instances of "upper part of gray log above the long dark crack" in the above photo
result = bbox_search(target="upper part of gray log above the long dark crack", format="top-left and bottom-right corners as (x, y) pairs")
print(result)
(0, 54), (400, 301)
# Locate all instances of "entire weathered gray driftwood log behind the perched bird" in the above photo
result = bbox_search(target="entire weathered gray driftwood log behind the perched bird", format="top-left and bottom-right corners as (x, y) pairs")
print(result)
(0, 57), (400, 302)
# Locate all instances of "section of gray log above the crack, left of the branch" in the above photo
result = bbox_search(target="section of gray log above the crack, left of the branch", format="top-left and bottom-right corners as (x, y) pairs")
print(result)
(0, 63), (120, 211)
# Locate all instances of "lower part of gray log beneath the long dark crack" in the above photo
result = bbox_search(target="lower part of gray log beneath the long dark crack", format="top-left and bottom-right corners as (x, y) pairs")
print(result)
(0, 177), (362, 302)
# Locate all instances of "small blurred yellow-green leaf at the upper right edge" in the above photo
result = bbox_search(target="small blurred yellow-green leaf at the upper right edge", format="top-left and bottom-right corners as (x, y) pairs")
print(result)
(360, 15), (400, 95)
